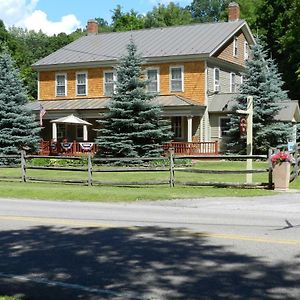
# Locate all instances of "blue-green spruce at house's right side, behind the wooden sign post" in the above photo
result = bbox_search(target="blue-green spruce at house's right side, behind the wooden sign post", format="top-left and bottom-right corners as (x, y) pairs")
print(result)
(227, 41), (291, 153)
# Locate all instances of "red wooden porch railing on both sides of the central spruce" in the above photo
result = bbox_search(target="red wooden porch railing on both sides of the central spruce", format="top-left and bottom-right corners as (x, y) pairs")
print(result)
(38, 140), (218, 156)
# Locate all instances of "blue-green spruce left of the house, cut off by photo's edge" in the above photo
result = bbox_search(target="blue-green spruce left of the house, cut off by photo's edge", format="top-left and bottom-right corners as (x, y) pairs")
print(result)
(0, 52), (40, 159)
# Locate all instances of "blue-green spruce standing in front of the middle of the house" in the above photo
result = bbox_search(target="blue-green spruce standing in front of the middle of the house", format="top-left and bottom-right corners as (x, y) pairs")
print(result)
(96, 41), (171, 161)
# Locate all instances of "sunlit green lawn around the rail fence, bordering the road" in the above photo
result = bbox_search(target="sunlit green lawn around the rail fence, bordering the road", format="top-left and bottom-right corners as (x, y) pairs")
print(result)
(0, 161), (300, 201)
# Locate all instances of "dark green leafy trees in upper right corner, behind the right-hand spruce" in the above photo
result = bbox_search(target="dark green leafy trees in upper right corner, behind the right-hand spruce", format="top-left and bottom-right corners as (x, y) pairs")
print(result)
(256, 0), (300, 99)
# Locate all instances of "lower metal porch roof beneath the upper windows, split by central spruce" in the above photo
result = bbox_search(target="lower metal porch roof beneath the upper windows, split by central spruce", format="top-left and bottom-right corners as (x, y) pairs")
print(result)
(27, 95), (204, 111)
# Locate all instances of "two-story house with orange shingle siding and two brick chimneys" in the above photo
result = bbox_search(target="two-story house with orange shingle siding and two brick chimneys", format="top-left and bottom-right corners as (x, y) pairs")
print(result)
(30, 3), (255, 155)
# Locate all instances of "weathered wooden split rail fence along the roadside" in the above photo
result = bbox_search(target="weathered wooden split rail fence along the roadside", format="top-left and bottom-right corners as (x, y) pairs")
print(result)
(0, 149), (299, 189)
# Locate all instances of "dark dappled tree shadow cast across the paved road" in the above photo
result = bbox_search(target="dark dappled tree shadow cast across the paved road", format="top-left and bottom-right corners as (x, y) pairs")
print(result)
(0, 226), (300, 300)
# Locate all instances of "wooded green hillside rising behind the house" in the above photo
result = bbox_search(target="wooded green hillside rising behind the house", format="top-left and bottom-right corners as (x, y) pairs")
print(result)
(0, 0), (300, 100)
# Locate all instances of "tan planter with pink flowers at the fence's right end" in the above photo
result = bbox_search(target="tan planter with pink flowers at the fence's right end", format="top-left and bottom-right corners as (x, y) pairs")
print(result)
(271, 151), (291, 190)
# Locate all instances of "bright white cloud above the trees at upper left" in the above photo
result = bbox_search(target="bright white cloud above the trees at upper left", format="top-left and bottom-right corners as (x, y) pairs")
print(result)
(0, 0), (80, 35)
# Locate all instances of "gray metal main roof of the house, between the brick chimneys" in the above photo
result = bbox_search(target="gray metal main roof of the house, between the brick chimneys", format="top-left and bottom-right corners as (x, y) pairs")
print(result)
(33, 21), (246, 68)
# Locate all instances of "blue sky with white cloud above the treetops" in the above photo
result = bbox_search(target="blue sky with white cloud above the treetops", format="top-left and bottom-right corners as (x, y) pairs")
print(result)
(0, 0), (191, 35)
